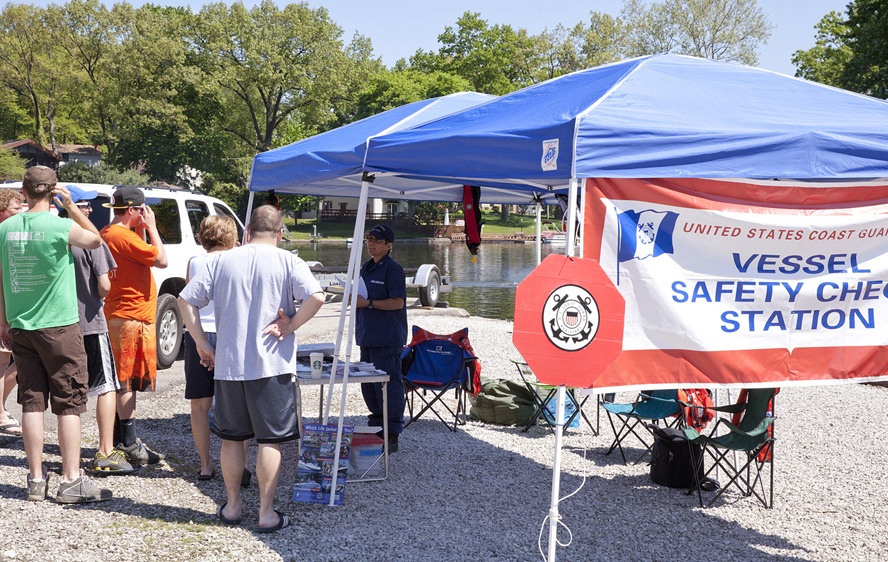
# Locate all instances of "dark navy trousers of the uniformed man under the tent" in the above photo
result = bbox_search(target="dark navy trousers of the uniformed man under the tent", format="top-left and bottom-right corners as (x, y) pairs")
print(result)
(361, 347), (407, 434)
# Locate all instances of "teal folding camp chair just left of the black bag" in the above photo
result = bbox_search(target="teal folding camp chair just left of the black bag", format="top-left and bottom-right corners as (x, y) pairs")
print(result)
(601, 389), (681, 464)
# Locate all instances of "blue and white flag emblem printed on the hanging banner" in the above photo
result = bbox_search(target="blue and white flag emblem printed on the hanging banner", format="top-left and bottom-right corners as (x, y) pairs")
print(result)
(617, 209), (678, 261)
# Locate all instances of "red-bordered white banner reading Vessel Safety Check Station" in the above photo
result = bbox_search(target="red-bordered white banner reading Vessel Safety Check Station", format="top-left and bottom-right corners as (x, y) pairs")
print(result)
(583, 179), (888, 388)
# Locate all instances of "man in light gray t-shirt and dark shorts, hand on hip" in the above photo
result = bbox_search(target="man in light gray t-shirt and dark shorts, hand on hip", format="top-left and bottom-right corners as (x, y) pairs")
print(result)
(179, 205), (324, 533)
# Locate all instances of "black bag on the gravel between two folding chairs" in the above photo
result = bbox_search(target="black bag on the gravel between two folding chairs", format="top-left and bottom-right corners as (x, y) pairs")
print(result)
(648, 425), (703, 489)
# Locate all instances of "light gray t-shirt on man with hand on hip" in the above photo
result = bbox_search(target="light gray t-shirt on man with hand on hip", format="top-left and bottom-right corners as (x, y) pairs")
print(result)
(179, 244), (321, 381)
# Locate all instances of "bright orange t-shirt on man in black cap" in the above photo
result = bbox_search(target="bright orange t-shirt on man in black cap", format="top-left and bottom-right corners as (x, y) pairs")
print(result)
(101, 224), (158, 324)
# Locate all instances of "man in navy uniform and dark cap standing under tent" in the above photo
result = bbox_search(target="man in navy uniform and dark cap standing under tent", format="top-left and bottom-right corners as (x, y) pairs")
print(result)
(355, 224), (407, 453)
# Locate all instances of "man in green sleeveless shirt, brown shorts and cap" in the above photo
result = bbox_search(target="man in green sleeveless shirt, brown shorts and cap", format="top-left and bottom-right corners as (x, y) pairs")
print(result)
(0, 166), (112, 503)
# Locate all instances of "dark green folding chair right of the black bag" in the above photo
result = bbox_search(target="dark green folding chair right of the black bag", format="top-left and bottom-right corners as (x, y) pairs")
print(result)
(682, 388), (778, 508)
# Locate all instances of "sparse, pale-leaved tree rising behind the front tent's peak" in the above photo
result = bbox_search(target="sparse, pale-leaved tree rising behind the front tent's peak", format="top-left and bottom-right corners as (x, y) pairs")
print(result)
(620, 0), (772, 65)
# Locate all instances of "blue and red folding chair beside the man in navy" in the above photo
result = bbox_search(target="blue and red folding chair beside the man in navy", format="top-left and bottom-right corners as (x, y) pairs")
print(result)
(401, 326), (481, 431)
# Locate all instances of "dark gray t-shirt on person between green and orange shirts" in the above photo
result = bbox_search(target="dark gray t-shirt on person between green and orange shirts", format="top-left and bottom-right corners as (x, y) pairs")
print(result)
(71, 241), (117, 336)
